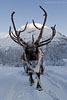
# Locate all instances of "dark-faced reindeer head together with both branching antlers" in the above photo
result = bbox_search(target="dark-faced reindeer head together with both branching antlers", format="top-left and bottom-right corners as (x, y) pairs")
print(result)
(9, 6), (56, 59)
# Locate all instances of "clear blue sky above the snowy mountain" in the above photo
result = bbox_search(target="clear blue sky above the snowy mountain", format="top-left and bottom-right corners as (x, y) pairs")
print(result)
(0, 0), (67, 36)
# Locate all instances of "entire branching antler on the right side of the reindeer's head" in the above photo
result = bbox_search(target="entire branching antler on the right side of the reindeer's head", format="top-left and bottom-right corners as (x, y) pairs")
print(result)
(33, 6), (56, 47)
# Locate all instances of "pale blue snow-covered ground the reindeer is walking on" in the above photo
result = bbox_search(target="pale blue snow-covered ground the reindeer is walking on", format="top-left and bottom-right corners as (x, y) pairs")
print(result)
(0, 66), (67, 100)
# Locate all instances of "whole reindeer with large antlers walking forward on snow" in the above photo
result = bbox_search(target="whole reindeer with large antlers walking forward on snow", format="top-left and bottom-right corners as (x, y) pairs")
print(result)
(9, 6), (56, 90)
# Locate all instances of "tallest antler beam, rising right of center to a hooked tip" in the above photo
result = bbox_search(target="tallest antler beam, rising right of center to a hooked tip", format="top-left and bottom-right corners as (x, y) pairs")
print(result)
(34, 6), (47, 45)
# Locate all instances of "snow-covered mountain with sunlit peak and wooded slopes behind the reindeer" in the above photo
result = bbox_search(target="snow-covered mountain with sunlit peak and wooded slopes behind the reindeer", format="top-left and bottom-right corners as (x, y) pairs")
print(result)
(0, 23), (67, 67)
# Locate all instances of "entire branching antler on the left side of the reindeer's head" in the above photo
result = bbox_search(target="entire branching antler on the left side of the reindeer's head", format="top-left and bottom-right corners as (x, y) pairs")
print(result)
(9, 11), (28, 47)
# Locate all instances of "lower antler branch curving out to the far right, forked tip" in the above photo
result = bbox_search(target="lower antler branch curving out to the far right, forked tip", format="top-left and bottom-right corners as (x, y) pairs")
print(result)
(38, 25), (56, 47)
